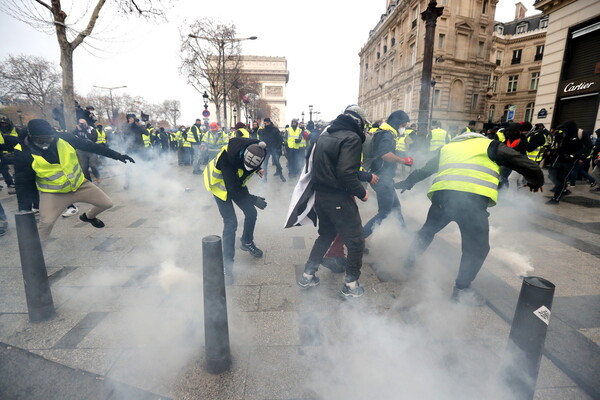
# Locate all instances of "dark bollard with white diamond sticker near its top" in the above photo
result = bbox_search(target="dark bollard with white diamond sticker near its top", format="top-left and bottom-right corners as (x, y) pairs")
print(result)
(505, 276), (555, 400)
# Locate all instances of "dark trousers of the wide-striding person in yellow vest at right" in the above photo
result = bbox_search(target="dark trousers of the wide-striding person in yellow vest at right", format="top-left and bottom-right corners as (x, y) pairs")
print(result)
(405, 191), (490, 289)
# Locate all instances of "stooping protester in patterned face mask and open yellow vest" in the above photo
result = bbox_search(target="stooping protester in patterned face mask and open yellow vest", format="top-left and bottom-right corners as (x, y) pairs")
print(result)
(204, 138), (267, 284)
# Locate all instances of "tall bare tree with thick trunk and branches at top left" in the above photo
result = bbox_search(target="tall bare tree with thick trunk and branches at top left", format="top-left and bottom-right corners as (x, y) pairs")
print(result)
(0, 0), (170, 129)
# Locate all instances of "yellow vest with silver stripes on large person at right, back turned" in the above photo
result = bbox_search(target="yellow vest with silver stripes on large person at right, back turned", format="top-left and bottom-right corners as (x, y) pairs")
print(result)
(428, 137), (500, 207)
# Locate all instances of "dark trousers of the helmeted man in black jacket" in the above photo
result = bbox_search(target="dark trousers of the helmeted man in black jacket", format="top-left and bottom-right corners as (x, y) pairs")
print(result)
(304, 192), (365, 282)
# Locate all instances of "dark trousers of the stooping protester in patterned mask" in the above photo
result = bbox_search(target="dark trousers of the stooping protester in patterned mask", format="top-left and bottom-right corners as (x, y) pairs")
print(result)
(214, 193), (258, 266)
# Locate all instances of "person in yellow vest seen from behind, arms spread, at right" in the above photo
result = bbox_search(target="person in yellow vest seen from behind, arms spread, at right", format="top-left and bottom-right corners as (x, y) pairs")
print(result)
(395, 132), (544, 305)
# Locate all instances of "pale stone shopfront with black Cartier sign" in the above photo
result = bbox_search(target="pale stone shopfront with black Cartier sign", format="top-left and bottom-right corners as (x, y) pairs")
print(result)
(533, 0), (600, 132)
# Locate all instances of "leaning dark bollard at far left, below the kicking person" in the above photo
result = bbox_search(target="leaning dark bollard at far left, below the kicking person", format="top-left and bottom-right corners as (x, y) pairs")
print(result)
(15, 212), (56, 322)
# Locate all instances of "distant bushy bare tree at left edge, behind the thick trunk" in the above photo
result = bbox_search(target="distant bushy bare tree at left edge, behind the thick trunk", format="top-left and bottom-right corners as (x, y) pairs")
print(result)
(0, 55), (60, 118)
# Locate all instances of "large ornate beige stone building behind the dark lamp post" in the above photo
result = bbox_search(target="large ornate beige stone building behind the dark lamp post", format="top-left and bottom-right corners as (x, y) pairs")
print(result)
(359, 0), (497, 132)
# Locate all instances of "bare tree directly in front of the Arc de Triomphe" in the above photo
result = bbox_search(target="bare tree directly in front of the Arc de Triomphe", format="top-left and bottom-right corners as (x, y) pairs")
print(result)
(180, 18), (241, 123)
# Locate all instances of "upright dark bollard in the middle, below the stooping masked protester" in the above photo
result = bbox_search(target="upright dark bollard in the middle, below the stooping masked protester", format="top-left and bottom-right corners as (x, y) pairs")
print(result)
(202, 235), (231, 374)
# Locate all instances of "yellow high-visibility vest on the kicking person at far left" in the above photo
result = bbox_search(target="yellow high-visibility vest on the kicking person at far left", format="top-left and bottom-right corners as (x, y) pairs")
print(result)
(15, 139), (85, 193)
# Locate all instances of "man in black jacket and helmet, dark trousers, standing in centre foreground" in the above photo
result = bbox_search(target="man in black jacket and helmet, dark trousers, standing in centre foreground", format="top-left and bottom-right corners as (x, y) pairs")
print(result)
(298, 105), (369, 297)
